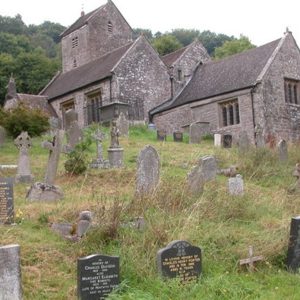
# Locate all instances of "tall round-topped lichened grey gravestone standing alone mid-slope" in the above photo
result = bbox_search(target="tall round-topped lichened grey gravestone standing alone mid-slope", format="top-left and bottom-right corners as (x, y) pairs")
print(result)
(136, 145), (160, 196)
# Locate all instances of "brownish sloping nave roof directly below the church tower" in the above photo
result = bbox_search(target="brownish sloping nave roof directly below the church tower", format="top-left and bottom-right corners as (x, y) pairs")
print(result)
(42, 43), (133, 100)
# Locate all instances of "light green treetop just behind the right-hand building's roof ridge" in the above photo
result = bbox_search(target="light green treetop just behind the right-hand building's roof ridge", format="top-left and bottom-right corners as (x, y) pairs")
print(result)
(215, 35), (255, 59)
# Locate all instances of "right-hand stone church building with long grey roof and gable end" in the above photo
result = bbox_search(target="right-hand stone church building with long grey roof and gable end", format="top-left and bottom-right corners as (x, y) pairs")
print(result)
(150, 31), (300, 143)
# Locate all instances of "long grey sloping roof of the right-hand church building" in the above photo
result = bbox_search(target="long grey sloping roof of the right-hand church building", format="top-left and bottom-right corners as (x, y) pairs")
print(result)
(150, 39), (281, 115)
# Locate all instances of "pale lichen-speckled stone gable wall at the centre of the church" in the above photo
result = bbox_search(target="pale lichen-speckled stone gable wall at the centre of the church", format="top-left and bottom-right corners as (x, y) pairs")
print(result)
(113, 36), (171, 121)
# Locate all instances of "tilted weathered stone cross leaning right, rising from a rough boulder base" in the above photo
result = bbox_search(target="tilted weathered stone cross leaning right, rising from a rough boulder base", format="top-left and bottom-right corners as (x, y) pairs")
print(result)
(42, 129), (64, 185)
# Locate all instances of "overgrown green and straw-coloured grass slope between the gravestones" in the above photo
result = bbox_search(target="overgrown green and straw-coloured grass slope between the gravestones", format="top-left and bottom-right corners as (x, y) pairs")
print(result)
(0, 127), (300, 300)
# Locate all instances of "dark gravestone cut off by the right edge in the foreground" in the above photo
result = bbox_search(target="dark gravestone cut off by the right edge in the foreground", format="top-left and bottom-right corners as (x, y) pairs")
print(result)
(286, 216), (300, 273)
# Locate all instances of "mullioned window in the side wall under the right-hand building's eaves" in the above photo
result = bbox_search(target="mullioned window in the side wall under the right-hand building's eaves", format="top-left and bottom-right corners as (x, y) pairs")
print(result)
(219, 99), (240, 127)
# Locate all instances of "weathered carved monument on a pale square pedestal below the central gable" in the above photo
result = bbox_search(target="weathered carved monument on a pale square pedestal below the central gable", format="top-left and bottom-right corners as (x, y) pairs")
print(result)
(107, 121), (124, 168)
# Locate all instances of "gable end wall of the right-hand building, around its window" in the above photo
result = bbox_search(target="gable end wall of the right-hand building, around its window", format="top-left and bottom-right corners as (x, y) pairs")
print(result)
(254, 34), (300, 141)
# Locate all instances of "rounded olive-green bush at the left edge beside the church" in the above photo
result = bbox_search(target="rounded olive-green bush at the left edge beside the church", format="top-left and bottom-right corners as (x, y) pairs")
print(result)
(0, 105), (49, 138)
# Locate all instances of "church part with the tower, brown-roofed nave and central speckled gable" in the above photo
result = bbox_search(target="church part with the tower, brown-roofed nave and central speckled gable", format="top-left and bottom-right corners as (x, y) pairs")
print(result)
(40, 0), (209, 127)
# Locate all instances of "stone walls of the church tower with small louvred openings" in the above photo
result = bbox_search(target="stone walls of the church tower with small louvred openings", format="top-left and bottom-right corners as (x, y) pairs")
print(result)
(62, 1), (132, 72)
